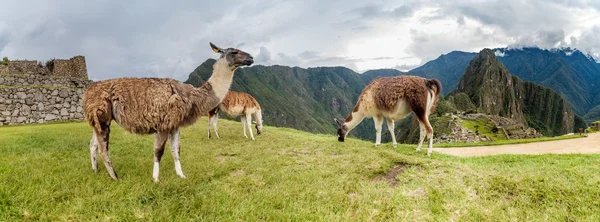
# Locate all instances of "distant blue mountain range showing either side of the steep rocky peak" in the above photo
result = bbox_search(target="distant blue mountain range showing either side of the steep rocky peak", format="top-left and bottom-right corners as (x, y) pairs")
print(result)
(409, 47), (600, 122)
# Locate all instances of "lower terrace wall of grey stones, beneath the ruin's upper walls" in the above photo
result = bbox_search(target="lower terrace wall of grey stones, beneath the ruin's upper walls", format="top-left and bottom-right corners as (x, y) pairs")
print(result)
(0, 88), (84, 125)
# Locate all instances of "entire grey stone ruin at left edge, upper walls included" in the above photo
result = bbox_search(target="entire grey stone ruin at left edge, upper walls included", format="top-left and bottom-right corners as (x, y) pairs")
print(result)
(0, 56), (91, 125)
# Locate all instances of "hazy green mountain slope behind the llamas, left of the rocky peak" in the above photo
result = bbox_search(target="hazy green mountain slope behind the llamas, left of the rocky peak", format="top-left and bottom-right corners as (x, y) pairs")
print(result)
(186, 59), (404, 140)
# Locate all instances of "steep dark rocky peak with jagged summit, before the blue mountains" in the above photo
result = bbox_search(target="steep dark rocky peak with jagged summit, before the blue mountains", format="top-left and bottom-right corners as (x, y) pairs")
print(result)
(450, 49), (583, 136)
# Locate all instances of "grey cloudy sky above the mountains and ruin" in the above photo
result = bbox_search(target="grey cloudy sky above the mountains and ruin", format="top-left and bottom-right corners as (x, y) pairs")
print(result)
(0, 0), (600, 81)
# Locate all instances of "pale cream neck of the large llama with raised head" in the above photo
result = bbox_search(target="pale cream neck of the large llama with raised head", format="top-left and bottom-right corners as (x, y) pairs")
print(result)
(207, 58), (235, 101)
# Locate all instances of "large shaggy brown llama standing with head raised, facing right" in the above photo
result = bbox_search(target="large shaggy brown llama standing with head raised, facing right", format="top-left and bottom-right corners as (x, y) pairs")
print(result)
(83, 43), (254, 182)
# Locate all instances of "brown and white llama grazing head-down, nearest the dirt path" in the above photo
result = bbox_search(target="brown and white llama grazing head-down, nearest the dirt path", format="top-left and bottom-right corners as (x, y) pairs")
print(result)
(334, 76), (442, 155)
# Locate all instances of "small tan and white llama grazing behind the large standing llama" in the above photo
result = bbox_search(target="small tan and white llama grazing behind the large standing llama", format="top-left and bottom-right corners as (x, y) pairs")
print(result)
(208, 91), (262, 140)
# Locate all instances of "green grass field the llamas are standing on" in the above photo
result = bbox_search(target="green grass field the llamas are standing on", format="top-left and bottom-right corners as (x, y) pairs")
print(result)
(0, 118), (600, 221)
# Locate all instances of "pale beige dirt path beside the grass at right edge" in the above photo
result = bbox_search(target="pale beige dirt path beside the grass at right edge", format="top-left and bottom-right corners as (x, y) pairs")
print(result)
(433, 133), (600, 157)
